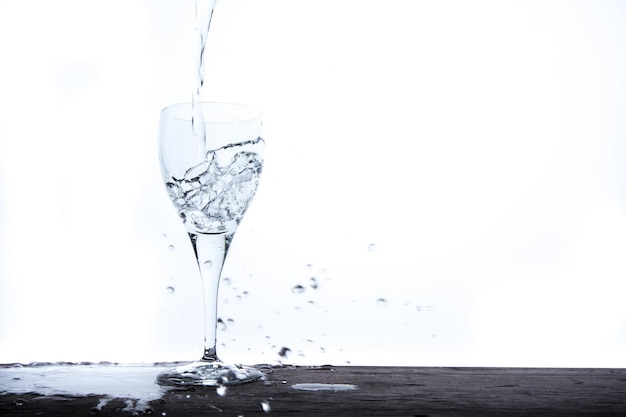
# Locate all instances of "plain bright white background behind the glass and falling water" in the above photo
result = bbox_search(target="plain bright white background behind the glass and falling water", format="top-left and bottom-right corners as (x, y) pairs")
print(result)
(0, 0), (626, 367)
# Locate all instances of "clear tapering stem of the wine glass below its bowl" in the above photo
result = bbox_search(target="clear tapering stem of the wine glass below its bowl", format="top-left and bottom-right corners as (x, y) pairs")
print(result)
(189, 232), (234, 362)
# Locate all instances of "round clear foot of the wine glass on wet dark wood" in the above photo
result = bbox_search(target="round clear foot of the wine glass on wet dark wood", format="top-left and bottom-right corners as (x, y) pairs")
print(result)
(157, 360), (263, 387)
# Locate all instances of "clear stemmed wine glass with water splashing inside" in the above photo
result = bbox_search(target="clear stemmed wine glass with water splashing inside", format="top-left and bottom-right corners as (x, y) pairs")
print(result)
(157, 102), (265, 386)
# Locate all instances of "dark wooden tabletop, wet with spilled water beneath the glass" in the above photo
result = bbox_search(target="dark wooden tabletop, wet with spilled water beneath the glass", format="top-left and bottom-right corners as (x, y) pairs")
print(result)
(0, 366), (626, 417)
